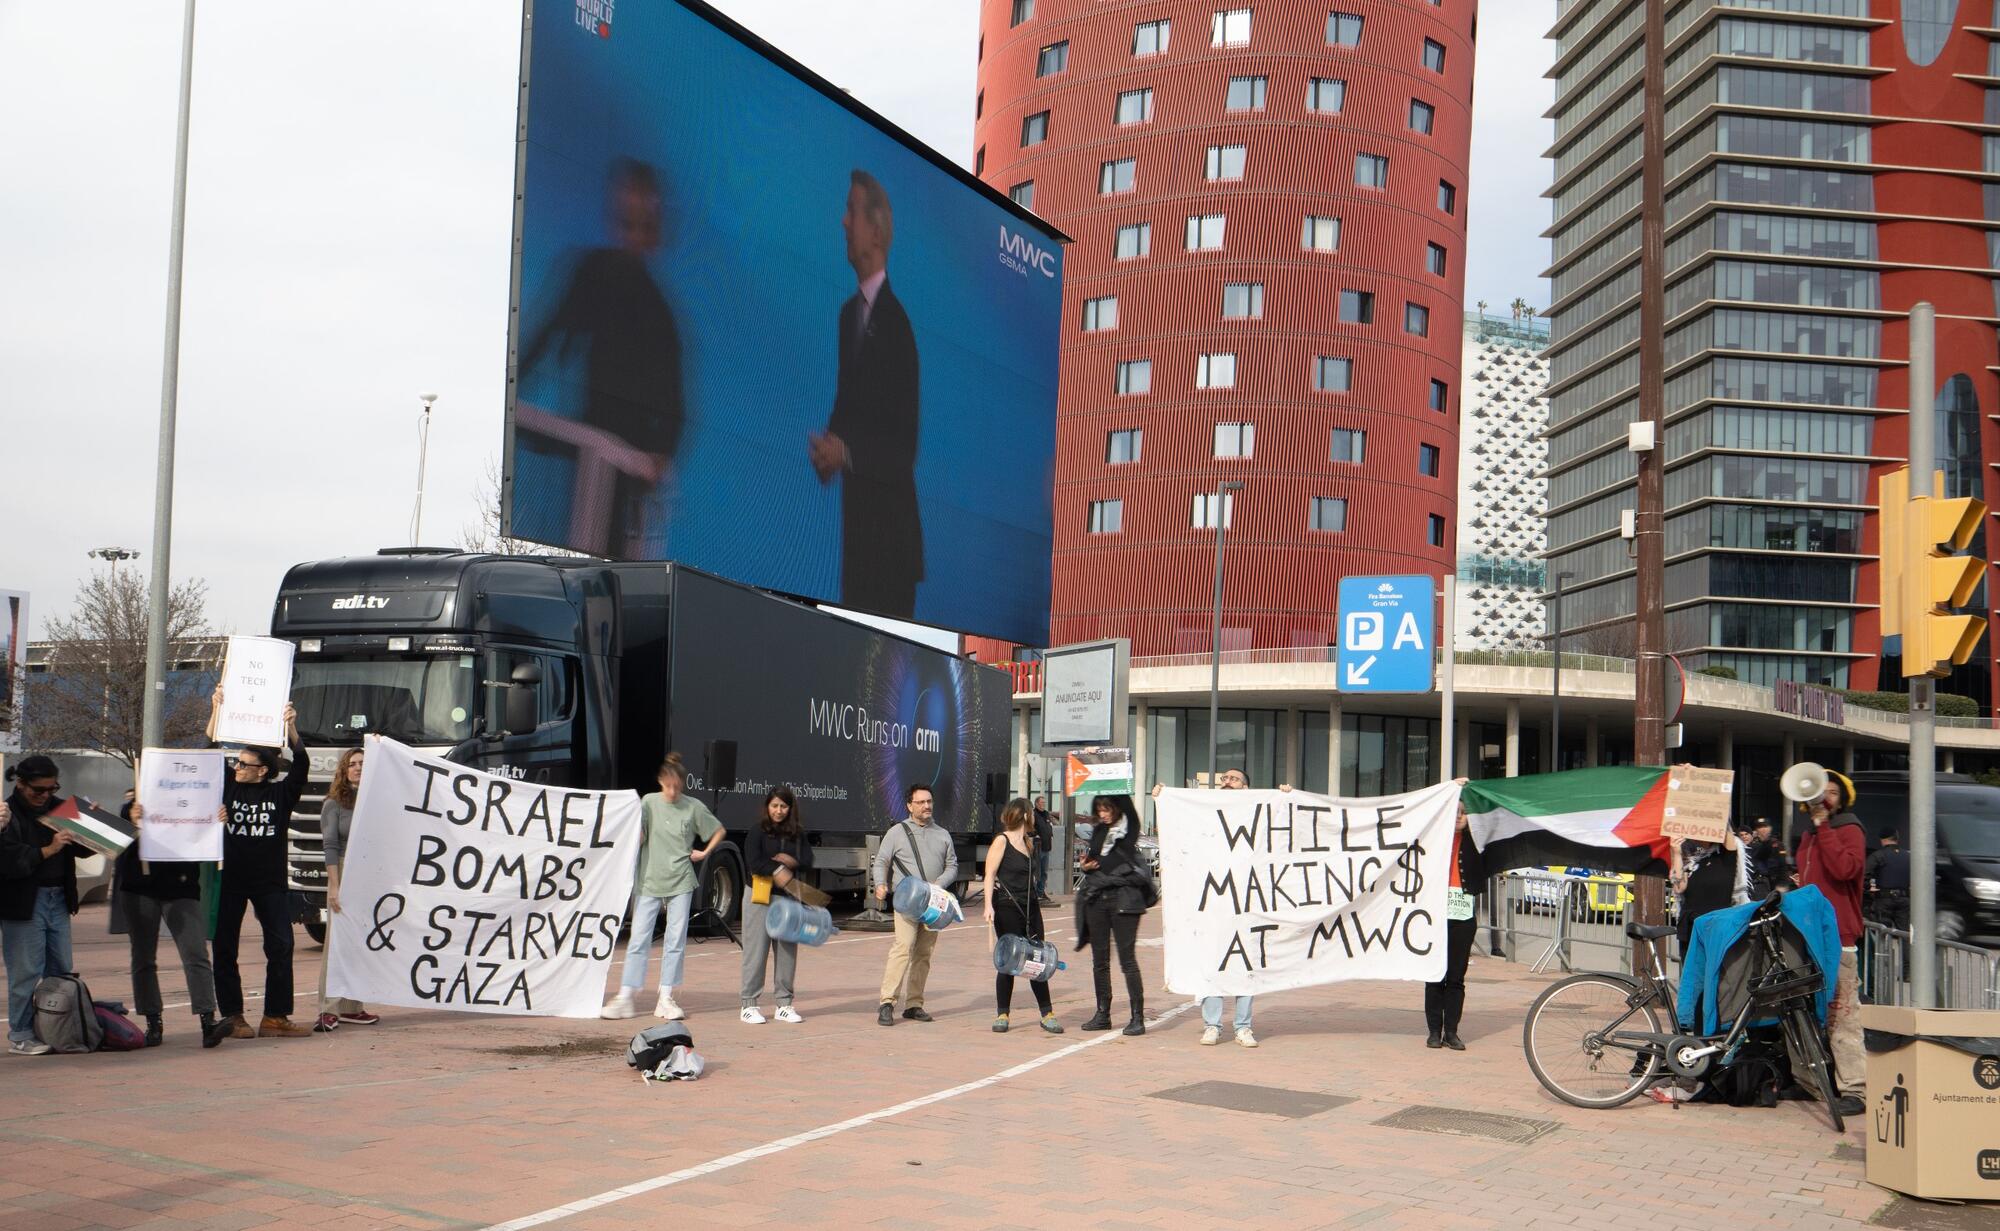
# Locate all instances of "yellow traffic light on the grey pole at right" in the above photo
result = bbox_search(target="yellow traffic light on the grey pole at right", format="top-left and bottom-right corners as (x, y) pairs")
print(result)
(1884, 480), (1986, 679)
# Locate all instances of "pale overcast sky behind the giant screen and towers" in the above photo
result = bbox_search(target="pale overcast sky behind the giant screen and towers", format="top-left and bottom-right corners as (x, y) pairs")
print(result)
(0, 0), (1554, 637)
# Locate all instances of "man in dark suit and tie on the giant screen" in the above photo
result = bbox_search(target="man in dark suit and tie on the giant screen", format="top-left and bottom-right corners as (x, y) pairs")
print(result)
(808, 170), (924, 619)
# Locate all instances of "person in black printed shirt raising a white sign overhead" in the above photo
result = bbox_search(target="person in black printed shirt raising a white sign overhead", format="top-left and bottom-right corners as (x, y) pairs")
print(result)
(208, 685), (312, 1039)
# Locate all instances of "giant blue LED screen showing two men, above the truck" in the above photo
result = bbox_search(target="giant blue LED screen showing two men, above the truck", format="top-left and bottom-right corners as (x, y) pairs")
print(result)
(508, 0), (1062, 645)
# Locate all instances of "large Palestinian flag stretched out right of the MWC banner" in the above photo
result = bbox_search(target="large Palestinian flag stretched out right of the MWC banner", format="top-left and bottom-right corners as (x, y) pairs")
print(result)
(1460, 765), (1672, 873)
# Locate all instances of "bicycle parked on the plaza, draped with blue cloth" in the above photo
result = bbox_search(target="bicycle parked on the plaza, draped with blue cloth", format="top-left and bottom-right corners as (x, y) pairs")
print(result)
(1522, 893), (1844, 1133)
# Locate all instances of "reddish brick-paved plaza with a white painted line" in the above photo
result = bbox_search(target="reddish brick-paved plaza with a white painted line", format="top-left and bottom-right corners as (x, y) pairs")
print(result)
(0, 907), (1944, 1231)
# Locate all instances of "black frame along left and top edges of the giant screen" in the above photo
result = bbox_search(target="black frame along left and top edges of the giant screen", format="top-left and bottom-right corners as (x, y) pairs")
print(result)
(500, 0), (1072, 547)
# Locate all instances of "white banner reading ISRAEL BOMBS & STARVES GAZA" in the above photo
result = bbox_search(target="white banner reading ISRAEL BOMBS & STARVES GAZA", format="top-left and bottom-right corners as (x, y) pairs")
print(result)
(326, 735), (640, 1017)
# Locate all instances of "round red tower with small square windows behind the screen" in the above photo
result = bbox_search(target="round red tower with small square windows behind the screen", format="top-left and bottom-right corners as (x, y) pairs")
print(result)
(974, 0), (1478, 653)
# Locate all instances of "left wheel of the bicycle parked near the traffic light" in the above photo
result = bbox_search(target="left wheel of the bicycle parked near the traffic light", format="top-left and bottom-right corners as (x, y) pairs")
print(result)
(1520, 973), (1660, 1107)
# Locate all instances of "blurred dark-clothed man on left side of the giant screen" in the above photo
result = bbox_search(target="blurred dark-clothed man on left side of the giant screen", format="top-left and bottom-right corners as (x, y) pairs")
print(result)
(518, 158), (684, 560)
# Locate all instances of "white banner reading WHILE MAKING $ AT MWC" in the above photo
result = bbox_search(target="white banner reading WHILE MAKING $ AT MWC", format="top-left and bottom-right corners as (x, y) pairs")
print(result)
(1156, 781), (1458, 995)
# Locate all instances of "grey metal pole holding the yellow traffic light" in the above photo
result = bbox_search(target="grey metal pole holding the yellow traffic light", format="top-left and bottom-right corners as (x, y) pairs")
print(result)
(1882, 304), (1940, 1009)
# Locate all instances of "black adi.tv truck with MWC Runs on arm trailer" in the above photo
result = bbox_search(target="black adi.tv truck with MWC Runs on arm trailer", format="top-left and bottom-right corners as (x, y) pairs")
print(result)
(270, 548), (1012, 939)
